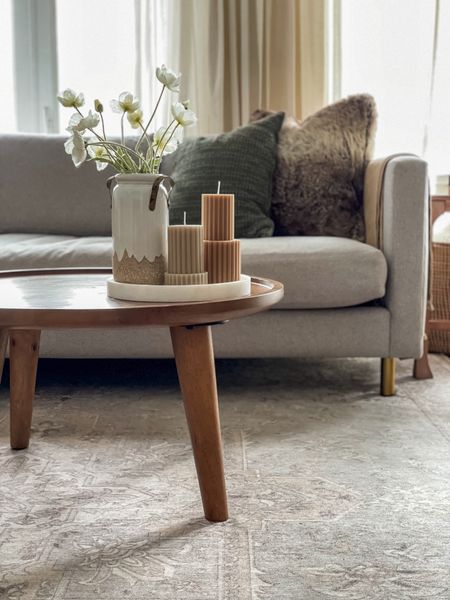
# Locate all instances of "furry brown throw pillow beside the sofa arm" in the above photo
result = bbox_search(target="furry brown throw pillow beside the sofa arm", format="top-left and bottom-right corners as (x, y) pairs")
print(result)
(251, 94), (377, 240)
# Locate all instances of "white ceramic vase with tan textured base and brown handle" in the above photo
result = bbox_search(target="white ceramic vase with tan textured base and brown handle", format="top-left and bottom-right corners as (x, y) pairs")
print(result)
(112, 173), (172, 285)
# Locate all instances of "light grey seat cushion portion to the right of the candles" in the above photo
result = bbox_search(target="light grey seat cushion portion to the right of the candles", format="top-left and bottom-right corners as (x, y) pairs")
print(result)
(241, 236), (387, 308)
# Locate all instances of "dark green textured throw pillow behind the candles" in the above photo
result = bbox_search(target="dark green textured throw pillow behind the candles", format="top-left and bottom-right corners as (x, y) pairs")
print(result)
(170, 112), (284, 238)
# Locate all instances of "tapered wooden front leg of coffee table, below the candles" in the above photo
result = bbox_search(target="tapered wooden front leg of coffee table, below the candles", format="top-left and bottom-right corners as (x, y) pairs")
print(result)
(170, 325), (228, 521)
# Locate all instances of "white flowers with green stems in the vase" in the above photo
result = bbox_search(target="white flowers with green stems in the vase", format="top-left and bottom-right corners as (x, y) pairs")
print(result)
(58, 65), (197, 173)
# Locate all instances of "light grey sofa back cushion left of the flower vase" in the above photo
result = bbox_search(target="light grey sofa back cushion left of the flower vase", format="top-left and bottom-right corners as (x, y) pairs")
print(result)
(0, 134), (113, 236)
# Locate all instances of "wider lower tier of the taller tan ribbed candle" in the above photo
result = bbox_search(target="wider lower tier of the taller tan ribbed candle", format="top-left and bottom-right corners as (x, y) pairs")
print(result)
(204, 240), (241, 283)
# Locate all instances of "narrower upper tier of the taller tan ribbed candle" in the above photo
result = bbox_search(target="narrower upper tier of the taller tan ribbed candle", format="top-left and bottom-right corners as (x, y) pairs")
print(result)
(202, 194), (234, 240)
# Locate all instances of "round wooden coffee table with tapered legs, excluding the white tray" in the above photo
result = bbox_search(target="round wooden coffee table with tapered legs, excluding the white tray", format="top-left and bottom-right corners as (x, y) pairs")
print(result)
(0, 269), (283, 521)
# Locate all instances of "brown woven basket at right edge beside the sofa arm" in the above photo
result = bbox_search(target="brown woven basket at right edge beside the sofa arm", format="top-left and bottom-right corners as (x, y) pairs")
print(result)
(428, 243), (450, 354)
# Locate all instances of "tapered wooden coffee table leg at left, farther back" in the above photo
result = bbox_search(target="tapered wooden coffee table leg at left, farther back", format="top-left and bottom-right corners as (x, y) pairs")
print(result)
(9, 329), (40, 450)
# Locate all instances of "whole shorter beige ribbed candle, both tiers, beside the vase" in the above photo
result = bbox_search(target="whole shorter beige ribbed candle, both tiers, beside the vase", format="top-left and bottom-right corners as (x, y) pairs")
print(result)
(164, 225), (208, 285)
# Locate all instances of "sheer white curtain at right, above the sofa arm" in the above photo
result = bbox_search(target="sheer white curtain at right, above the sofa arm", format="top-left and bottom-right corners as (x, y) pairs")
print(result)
(340, 0), (450, 181)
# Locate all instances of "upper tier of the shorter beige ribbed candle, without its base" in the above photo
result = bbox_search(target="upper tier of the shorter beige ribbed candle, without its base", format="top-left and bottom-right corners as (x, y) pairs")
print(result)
(167, 225), (205, 273)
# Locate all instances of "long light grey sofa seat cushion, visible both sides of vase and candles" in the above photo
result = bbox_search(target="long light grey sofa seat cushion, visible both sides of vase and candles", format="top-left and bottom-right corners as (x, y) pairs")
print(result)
(0, 234), (387, 309)
